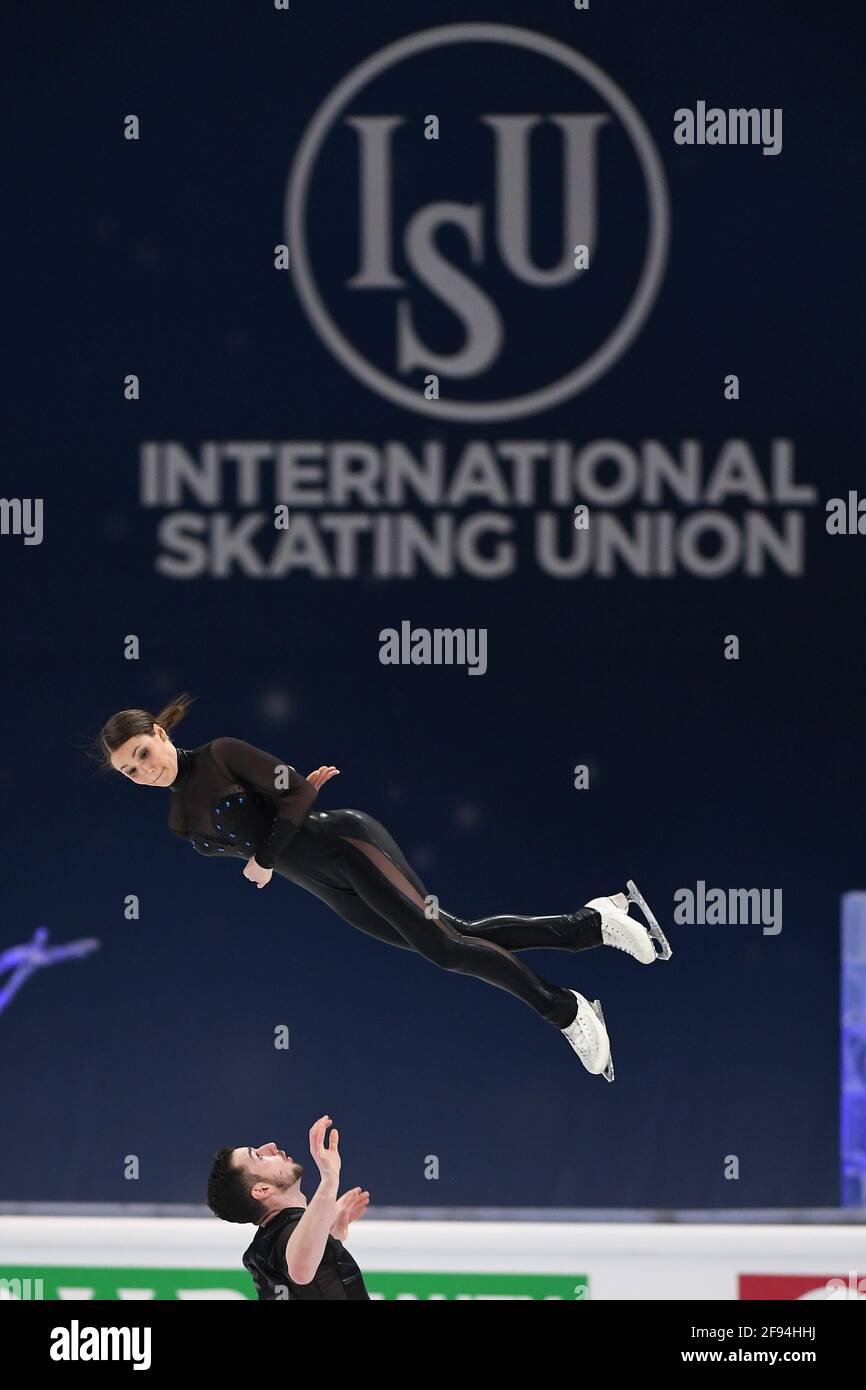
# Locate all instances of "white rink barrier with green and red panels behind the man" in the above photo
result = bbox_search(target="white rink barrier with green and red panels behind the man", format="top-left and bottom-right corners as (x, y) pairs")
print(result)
(0, 1213), (866, 1301)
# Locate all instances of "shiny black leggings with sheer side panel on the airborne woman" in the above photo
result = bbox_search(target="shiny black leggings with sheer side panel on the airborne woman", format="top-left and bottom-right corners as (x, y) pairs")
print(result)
(301, 826), (602, 1029)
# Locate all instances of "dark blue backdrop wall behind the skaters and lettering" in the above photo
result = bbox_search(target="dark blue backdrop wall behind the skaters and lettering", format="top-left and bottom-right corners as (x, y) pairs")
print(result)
(0, 0), (866, 1207)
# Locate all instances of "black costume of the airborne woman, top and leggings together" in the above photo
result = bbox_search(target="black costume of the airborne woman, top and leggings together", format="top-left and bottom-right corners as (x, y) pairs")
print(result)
(168, 738), (602, 1029)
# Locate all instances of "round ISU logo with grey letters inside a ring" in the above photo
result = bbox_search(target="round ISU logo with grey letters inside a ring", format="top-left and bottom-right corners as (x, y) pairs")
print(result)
(285, 24), (669, 421)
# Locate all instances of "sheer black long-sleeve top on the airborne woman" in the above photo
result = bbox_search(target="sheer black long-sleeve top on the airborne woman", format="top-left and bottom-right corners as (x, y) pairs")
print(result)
(168, 738), (318, 869)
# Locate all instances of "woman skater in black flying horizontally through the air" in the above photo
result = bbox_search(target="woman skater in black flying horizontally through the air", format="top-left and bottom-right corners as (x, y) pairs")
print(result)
(97, 695), (670, 1080)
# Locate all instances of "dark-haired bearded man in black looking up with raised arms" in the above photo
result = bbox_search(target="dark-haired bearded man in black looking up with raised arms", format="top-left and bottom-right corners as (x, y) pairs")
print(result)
(207, 1115), (370, 1301)
